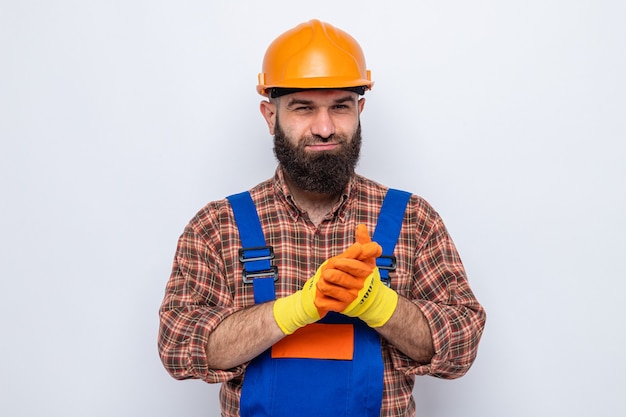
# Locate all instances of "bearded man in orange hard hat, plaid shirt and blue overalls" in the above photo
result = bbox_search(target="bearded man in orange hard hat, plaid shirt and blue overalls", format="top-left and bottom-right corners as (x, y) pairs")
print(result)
(159, 20), (485, 417)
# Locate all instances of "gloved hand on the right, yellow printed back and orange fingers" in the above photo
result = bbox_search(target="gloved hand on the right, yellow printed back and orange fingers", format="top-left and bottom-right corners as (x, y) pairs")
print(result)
(317, 225), (398, 327)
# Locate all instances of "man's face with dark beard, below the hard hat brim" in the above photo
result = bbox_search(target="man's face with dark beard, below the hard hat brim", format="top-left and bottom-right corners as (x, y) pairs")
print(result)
(260, 90), (363, 194)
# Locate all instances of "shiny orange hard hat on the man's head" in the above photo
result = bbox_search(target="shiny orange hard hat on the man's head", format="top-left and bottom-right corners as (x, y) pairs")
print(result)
(256, 19), (374, 97)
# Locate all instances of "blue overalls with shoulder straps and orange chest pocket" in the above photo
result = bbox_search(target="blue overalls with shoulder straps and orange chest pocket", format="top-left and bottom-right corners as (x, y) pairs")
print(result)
(228, 189), (411, 417)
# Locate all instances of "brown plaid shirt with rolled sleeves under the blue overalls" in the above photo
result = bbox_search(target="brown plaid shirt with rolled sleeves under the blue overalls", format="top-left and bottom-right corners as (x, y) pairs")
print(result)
(158, 168), (486, 417)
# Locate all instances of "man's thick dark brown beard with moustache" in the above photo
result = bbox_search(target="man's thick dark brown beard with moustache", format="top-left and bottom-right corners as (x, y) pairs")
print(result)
(274, 117), (361, 194)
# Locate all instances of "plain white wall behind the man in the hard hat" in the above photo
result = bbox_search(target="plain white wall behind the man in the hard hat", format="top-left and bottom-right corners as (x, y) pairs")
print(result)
(0, 0), (626, 417)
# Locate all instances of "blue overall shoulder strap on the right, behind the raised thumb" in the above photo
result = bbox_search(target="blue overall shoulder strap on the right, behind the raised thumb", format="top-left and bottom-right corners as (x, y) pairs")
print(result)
(372, 188), (411, 286)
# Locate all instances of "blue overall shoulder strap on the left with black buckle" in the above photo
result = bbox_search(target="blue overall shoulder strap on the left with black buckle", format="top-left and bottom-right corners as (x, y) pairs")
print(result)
(227, 191), (278, 304)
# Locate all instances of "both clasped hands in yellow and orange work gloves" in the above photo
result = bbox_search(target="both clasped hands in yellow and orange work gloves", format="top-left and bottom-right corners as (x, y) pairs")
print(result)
(274, 224), (398, 334)
